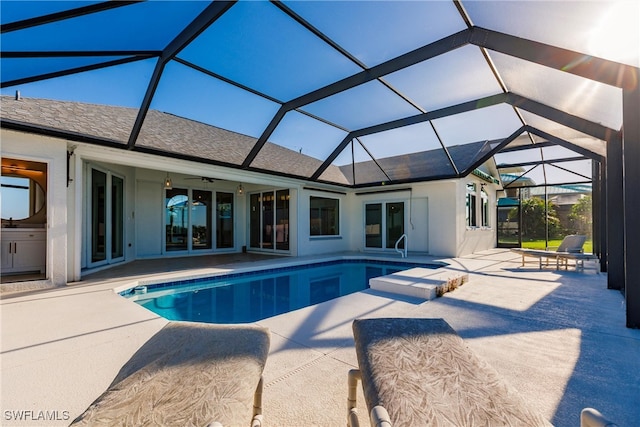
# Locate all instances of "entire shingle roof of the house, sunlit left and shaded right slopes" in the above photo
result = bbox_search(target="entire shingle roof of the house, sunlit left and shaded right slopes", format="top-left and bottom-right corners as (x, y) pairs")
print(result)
(0, 96), (496, 185)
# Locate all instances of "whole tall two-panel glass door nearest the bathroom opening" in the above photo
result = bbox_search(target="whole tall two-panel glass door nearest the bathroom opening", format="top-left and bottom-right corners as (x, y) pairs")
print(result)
(89, 168), (124, 266)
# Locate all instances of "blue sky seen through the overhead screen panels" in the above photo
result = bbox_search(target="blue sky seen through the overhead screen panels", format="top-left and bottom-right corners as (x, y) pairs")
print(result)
(1, 1), (640, 186)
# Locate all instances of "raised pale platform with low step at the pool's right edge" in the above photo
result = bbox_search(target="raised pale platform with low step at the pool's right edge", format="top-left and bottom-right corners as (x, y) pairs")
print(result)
(369, 267), (469, 300)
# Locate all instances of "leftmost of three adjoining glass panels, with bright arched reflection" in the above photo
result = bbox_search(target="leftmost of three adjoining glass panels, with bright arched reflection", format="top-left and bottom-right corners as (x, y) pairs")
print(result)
(165, 188), (189, 252)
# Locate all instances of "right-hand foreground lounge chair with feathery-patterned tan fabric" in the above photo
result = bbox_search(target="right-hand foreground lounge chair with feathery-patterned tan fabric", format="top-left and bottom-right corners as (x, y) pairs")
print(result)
(347, 318), (551, 427)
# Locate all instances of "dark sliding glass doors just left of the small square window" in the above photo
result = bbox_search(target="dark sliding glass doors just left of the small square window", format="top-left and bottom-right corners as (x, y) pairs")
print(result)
(249, 190), (290, 250)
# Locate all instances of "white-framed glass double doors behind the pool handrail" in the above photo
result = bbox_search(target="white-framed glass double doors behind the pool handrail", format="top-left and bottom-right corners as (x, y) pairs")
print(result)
(365, 202), (405, 249)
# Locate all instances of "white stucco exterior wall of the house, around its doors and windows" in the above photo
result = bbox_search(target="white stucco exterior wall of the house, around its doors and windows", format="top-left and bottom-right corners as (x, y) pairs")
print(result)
(2, 130), (497, 285)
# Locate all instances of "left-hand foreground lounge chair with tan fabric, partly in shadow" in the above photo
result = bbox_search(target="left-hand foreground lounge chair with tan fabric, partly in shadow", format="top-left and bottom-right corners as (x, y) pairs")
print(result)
(71, 322), (270, 427)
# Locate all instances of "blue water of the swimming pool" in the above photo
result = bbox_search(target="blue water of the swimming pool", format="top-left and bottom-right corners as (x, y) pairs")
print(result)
(123, 260), (439, 323)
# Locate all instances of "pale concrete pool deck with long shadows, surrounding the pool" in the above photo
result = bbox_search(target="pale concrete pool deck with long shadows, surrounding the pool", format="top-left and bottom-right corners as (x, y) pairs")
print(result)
(0, 249), (640, 427)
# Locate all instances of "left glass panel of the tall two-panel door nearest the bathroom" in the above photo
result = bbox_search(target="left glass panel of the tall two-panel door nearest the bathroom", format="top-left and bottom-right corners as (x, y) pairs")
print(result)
(91, 169), (107, 263)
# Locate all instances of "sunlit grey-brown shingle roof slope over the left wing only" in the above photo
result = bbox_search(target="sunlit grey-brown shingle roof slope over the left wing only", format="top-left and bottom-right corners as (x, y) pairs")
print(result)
(0, 96), (348, 184)
